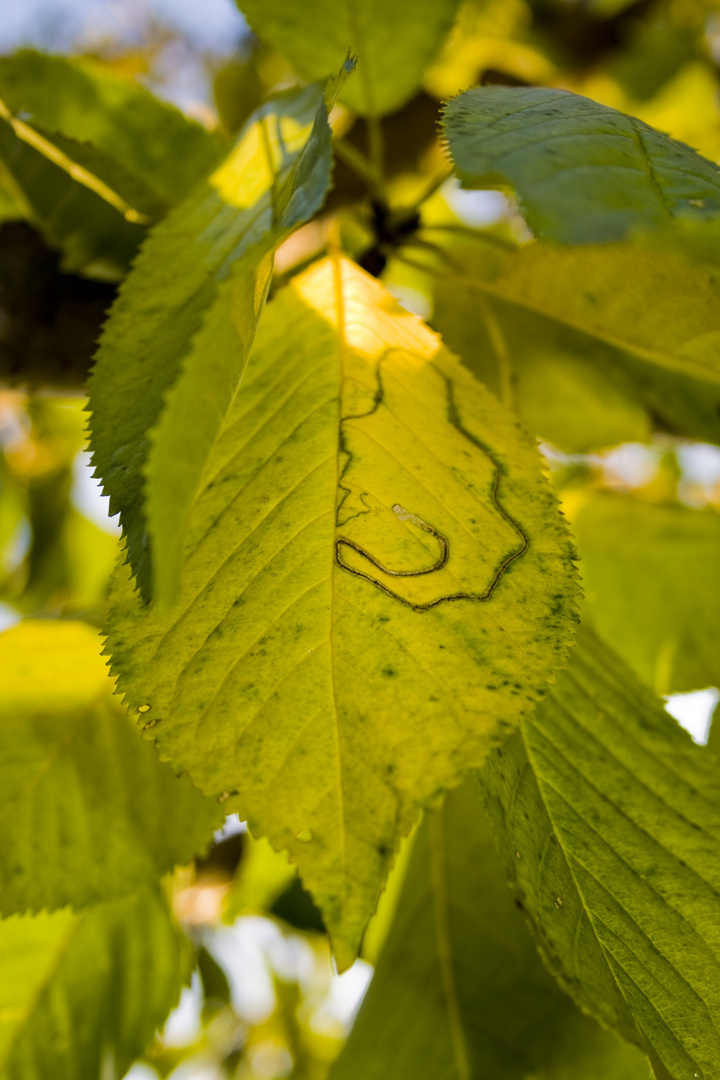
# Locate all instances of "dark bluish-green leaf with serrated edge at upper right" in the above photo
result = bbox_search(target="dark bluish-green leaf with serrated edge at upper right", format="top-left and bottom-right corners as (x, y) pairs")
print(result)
(444, 86), (720, 244)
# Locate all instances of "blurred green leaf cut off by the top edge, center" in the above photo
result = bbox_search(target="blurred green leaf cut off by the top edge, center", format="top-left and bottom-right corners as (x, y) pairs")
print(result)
(237, 0), (459, 117)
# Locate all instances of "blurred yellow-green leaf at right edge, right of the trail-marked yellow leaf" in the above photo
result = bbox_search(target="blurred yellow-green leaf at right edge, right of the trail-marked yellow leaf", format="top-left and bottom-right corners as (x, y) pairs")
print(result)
(573, 495), (720, 693)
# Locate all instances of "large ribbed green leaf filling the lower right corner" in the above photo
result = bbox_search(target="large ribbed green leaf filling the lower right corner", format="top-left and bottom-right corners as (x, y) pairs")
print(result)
(483, 630), (720, 1080)
